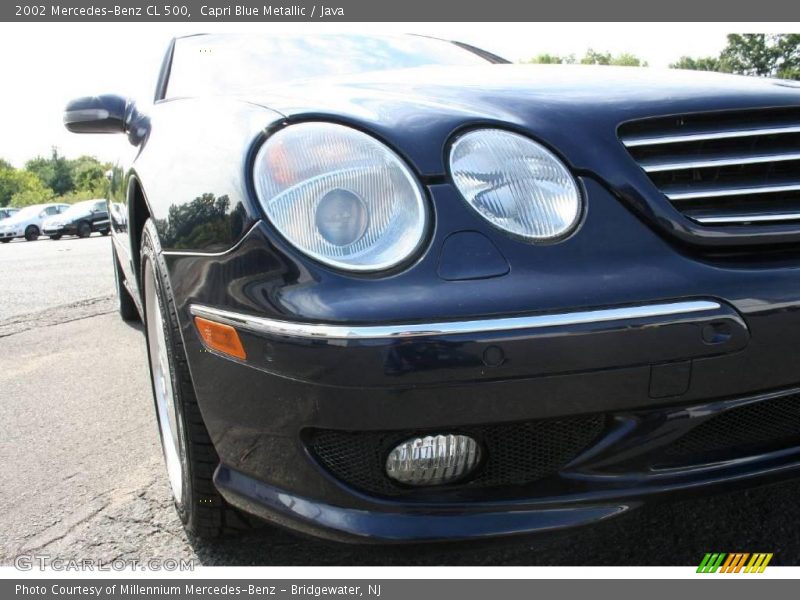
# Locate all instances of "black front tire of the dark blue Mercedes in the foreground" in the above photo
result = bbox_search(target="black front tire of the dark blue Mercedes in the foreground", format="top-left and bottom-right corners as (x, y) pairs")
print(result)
(140, 220), (250, 538)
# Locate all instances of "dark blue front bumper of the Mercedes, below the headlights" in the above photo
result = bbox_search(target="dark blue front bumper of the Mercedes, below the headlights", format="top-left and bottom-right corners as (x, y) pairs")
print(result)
(166, 182), (800, 541)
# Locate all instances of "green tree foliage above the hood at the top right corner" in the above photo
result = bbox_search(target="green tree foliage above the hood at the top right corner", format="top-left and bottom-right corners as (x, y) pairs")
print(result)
(670, 33), (800, 79)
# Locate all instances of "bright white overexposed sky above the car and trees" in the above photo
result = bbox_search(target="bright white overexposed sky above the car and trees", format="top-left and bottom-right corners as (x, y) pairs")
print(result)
(0, 23), (798, 167)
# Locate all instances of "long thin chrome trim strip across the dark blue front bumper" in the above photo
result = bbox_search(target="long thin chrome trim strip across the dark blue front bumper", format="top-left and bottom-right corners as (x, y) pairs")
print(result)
(189, 300), (722, 340)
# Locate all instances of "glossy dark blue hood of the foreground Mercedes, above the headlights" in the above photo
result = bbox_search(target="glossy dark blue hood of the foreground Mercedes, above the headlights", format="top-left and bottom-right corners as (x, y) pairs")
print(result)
(247, 65), (800, 175)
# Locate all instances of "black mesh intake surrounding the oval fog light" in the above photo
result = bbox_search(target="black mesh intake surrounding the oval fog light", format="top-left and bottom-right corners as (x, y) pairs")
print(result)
(306, 415), (604, 496)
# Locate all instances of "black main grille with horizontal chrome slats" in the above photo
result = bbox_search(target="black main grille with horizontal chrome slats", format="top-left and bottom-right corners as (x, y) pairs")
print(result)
(619, 107), (800, 227)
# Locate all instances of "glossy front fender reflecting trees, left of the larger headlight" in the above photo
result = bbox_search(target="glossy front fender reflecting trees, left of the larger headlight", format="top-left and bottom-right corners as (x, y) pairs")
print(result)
(133, 98), (283, 253)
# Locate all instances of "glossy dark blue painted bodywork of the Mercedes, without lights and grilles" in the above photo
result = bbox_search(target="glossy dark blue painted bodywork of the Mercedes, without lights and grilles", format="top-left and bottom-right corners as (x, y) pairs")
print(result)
(65, 34), (800, 541)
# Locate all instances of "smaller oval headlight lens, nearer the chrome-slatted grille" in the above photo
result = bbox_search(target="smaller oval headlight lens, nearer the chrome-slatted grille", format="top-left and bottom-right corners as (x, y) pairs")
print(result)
(450, 129), (582, 242)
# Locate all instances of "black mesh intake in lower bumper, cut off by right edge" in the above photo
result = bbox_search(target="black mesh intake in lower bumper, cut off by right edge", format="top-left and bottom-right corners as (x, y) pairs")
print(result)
(667, 395), (800, 462)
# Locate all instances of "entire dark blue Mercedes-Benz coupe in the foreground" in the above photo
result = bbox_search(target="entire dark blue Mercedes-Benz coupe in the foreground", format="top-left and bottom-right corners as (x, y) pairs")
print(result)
(64, 35), (800, 541)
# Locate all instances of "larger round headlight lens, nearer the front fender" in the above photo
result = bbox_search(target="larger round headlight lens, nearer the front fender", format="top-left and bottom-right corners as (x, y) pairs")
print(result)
(254, 123), (428, 271)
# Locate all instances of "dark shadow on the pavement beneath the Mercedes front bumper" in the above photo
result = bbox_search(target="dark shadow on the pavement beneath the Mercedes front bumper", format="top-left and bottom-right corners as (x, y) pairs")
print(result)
(183, 481), (800, 566)
